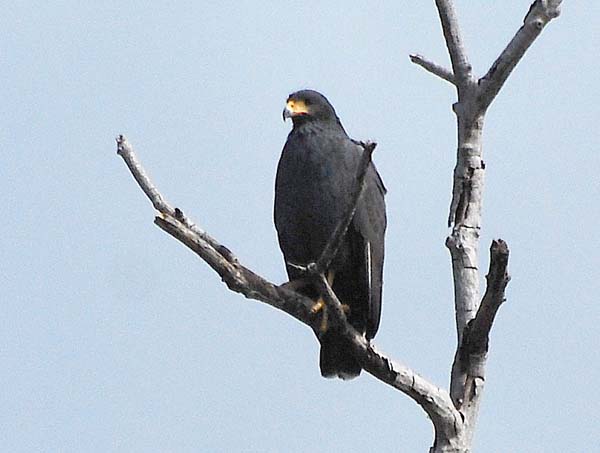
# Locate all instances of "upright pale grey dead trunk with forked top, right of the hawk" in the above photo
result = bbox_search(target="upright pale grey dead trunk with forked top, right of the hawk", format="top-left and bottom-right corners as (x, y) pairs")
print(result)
(410, 0), (561, 453)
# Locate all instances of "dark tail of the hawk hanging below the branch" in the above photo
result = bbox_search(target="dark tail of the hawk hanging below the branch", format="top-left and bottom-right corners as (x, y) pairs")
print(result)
(319, 330), (361, 379)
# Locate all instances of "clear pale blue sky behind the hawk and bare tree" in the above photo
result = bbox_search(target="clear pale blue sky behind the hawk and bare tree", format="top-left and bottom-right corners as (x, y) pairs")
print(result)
(0, 0), (600, 453)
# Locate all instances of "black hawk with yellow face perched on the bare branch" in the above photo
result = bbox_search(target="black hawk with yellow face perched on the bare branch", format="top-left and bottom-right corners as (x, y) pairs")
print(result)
(274, 89), (387, 379)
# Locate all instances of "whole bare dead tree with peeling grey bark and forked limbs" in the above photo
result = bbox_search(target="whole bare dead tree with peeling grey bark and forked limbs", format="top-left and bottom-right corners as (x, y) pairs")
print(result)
(117, 0), (562, 453)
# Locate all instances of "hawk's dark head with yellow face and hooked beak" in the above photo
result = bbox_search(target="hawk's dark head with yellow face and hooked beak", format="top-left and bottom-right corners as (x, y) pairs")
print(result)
(283, 90), (339, 125)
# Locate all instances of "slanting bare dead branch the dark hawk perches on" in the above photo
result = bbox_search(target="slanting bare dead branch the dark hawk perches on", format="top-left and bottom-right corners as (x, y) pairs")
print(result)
(117, 135), (461, 438)
